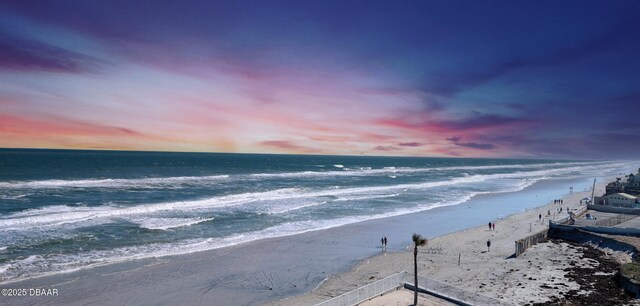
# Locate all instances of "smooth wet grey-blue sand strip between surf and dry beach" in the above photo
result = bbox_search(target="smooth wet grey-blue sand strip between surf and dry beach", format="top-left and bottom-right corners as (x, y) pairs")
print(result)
(0, 173), (612, 305)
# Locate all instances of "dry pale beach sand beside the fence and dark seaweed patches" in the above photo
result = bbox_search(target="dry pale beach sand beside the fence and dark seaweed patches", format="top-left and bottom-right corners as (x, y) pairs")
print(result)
(273, 180), (631, 305)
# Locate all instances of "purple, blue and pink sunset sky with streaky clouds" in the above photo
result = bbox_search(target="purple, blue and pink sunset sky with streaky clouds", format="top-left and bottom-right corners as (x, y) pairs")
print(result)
(0, 0), (640, 159)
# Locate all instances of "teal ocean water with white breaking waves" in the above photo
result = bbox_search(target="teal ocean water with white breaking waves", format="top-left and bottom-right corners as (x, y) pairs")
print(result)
(0, 149), (637, 283)
